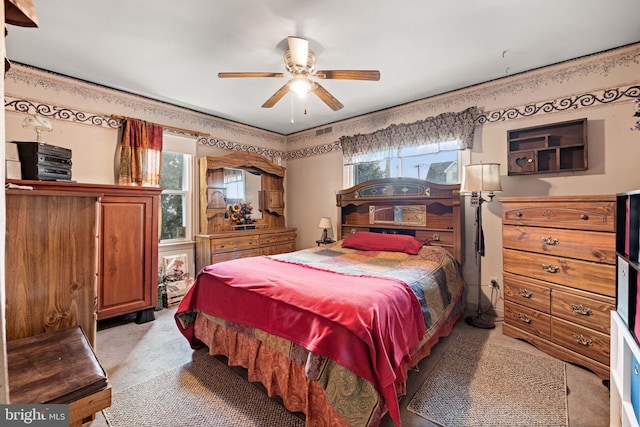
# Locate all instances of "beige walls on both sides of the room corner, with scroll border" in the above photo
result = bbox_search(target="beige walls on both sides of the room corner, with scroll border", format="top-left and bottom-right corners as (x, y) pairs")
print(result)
(5, 45), (640, 320)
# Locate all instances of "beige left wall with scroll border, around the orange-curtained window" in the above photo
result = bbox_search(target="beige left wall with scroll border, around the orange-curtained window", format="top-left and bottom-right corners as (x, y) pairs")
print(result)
(3, 65), (285, 274)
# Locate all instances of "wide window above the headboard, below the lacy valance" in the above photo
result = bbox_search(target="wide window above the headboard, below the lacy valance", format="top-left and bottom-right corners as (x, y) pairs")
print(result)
(350, 144), (464, 185)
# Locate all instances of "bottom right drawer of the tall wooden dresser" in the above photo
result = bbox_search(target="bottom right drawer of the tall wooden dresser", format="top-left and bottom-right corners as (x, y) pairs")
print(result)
(551, 317), (610, 366)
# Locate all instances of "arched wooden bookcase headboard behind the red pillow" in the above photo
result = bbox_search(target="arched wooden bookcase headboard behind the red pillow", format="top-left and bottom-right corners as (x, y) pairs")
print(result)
(336, 178), (464, 264)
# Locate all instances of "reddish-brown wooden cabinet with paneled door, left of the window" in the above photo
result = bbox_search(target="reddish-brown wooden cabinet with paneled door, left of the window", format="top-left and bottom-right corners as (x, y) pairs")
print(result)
(8, 180), (162, 323)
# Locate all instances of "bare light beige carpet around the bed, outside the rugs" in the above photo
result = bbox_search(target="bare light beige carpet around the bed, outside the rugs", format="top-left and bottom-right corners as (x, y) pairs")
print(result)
(91, 307), (609, 427)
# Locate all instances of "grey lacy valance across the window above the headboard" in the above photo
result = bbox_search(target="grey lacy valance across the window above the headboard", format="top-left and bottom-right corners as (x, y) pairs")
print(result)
(340, 107), (478, 165)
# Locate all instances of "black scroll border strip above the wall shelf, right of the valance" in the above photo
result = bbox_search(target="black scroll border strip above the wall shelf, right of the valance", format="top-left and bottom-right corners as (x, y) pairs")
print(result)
(476, 86), (640, 125)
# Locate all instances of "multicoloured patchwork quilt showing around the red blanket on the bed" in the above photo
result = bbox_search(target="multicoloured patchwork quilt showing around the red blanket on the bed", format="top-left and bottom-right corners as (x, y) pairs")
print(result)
(176, 242), (464, 426)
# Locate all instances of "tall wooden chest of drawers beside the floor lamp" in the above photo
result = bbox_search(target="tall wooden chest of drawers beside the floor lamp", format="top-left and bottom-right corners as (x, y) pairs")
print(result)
(499, 195), (616, 380)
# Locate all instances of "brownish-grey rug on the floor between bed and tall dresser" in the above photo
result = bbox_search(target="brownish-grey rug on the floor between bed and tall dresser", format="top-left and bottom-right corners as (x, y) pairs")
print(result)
(407, 335), (567, 427)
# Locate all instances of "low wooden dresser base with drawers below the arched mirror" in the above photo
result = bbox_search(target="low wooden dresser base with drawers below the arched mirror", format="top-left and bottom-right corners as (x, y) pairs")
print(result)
(196, 228), (296, 271)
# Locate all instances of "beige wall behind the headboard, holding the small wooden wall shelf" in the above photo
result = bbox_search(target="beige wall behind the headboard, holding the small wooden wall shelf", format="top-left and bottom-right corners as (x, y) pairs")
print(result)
(287, 44), (640, 315)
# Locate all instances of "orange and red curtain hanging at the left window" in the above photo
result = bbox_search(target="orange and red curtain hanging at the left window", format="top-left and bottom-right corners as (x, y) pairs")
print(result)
(119, 119), (163, 187)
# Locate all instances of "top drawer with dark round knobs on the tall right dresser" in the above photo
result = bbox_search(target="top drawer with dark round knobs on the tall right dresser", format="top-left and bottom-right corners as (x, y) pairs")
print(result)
(502, 200), (615, 232)
